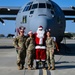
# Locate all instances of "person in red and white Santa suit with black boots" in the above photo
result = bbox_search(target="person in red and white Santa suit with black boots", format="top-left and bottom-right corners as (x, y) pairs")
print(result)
(35, 26), (46, 68)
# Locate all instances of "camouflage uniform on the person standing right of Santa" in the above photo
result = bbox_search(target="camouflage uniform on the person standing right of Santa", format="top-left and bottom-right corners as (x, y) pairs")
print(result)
(46, 37), (55, 69)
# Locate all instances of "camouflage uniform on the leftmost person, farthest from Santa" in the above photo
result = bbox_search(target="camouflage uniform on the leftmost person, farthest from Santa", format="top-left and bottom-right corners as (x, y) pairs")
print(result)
(13, 36), (26, 67)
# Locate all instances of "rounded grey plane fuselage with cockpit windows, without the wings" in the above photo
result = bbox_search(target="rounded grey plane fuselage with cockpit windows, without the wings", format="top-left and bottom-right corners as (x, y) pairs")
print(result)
(16, 0), (65, 42)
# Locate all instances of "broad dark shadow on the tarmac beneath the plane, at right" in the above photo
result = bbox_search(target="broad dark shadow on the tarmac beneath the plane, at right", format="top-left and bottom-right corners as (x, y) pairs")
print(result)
(55, 44), (75, 56)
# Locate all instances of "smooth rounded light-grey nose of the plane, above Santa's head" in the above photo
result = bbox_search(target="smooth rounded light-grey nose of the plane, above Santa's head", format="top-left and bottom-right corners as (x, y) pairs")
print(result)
(30, 17), (47, 32)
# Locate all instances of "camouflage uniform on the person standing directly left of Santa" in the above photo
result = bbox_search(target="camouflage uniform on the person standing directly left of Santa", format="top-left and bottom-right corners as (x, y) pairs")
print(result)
(26, 37), (35, 68)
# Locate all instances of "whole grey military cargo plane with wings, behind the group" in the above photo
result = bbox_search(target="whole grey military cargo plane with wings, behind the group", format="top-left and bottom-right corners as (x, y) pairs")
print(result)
(0, 0), (75, 43)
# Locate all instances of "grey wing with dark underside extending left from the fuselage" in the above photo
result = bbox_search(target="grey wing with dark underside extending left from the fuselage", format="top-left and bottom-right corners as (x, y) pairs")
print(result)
(0, 6), (20, 23)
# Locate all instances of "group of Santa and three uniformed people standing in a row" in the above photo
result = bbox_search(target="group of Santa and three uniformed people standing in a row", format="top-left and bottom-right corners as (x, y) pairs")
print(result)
(13, 26), (59, 70)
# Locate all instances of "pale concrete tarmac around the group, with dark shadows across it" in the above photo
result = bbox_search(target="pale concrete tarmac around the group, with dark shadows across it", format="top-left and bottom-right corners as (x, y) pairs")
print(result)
(0, 38), (75, 75)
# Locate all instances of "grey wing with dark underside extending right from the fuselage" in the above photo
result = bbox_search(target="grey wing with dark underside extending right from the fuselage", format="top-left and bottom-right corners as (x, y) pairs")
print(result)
(61, 6), (75, 21)
